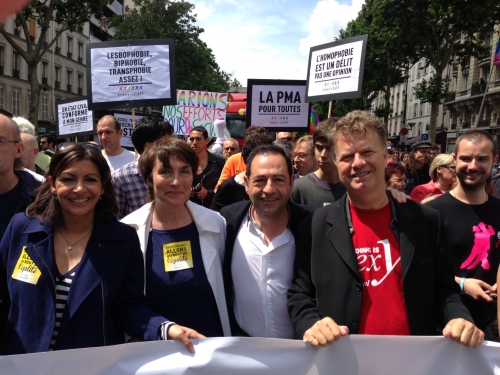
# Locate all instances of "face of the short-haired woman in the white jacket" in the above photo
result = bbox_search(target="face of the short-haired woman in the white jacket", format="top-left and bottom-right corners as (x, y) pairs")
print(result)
(151, 156), (193, 208)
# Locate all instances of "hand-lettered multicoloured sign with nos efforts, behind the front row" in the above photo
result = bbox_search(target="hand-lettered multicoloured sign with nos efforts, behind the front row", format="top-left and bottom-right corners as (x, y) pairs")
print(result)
(163, 89), (227, 137)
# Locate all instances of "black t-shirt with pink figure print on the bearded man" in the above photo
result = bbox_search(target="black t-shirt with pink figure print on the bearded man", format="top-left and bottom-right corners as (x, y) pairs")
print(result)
(427, 193), (500, 330)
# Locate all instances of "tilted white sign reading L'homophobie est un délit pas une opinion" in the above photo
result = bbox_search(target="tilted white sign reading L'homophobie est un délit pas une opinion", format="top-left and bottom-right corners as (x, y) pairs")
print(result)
(306, 35), (368, 103)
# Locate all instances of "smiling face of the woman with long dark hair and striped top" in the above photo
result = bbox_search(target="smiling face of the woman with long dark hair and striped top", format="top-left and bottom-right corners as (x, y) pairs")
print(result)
(49, 160), (104, 220)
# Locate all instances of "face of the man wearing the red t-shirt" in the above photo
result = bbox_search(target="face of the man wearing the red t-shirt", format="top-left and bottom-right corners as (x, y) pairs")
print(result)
(335, 129), (387, 196)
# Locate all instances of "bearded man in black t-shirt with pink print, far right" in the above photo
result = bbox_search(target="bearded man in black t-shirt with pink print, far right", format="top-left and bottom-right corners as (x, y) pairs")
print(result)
(429, 130), (500, 340)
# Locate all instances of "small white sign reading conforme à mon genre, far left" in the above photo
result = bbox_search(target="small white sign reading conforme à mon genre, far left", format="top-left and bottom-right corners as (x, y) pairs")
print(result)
(56, 98), (95, 138)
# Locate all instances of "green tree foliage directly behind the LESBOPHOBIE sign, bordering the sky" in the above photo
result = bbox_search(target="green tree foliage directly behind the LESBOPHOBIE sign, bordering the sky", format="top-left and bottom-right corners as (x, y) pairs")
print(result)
(109, 0), (231, 92)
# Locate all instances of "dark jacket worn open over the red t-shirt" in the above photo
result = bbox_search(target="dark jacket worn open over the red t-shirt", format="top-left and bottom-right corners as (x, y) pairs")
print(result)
(288, 195), (473, 339)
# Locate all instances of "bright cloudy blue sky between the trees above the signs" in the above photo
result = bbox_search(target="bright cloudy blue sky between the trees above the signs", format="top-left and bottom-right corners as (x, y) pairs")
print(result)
(191, 0), (364, 86)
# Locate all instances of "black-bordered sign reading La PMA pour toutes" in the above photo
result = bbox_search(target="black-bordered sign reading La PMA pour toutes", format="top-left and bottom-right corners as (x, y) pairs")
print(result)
(246, 79), (311, 132)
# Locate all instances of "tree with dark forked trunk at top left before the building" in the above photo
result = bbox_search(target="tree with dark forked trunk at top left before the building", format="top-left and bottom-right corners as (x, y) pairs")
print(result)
(0, 0), (108, 131)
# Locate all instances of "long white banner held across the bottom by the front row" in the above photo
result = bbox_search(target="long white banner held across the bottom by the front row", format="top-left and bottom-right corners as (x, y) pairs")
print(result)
(0, 335), (500, 375)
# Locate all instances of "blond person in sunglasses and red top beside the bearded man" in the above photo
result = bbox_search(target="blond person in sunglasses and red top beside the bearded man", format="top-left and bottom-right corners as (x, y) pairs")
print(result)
(410, 154), (457, 203)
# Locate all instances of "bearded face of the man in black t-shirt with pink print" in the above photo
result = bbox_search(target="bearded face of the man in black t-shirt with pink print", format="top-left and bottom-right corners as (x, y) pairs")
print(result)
(453, 139), (498, 191)
